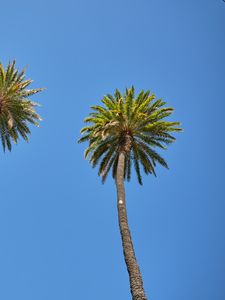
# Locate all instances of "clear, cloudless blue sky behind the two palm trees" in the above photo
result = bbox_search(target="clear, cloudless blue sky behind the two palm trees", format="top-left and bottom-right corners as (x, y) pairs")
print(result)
(0, 0), (225, 300)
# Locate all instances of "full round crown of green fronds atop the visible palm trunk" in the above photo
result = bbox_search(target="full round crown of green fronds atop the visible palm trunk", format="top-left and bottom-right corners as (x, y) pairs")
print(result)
(79, 87), (181, 184)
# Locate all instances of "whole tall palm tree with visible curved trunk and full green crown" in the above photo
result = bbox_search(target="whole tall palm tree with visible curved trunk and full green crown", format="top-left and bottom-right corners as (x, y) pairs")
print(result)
(79, 87), (181, 300)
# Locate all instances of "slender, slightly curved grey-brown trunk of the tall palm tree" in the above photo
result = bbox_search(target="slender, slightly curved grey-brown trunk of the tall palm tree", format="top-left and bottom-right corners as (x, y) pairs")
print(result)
(116, 152), (147, 300)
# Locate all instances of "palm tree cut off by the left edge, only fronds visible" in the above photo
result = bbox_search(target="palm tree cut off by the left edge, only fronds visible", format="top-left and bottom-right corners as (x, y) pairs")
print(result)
(0, 60), (43, 151)
